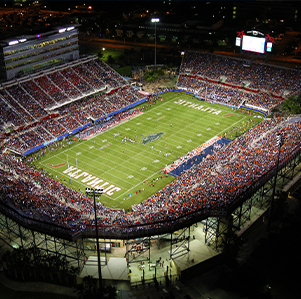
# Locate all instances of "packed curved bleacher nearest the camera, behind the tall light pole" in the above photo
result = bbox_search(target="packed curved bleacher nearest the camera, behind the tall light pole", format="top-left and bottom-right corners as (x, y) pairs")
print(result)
(0, 117), (301, 237)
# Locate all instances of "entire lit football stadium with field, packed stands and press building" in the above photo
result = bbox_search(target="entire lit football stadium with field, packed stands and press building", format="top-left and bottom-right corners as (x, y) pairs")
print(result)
(0, 27), (301, 283)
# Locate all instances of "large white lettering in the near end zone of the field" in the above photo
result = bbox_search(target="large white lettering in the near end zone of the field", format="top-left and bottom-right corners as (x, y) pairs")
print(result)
(63, 166), (121, 196)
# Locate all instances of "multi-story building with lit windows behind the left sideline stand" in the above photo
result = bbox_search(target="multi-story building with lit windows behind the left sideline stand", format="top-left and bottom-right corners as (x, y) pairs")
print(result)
(0, 25), (79, 80)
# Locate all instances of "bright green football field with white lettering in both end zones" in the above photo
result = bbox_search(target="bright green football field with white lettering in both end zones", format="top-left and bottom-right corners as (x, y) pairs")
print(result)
(36, 92), (260, 211)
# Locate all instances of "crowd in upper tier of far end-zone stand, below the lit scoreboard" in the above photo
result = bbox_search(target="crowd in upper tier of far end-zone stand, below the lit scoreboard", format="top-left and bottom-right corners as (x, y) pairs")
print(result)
(180, 52), (301, 95)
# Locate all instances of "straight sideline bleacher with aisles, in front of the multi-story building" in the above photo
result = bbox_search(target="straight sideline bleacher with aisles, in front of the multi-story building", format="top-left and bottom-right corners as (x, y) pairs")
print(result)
(0, 56), (142, 154)
